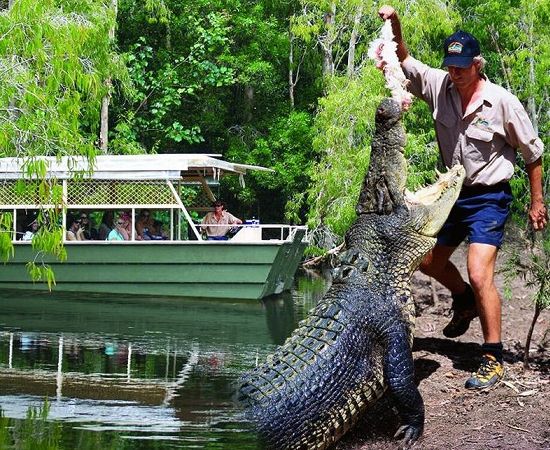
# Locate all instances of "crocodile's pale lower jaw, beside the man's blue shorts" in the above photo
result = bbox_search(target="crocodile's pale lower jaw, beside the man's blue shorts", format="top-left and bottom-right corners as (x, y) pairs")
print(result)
(405, 165), (465, 237)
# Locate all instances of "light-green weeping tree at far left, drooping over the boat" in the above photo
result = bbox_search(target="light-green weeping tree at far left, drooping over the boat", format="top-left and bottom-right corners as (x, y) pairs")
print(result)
(0, 0), (124, 284)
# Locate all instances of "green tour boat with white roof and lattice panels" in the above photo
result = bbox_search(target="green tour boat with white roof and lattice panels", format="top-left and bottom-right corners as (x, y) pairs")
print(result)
(0, 154), (307, 299)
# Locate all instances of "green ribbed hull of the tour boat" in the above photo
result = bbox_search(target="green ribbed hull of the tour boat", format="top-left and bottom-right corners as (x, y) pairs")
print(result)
(0, 239), (306, 299)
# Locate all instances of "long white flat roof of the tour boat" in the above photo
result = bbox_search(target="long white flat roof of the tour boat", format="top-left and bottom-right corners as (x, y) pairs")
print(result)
(0, 153), (273, 180)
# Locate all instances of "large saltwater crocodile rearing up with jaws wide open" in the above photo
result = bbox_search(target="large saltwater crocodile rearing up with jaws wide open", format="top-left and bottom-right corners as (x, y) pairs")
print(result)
(239, 99), (464, 450)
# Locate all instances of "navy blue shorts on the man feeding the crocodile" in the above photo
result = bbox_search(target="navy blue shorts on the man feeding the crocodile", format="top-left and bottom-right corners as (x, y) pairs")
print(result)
(437, 183), (512, 248)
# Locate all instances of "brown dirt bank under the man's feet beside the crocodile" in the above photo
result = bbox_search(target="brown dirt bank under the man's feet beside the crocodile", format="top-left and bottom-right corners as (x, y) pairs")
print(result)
(336, 244), (550, 450)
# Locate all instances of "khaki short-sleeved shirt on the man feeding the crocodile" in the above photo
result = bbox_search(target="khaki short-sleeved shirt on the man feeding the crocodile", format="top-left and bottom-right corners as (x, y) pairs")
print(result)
(403, 56), (544, 186)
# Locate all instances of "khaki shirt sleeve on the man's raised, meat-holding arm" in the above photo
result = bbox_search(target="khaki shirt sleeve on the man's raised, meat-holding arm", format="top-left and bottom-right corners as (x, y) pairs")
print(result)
(402, 56), (448, 110)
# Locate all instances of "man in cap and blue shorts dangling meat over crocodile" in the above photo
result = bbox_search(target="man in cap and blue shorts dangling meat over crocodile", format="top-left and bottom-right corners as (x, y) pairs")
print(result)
(379, 6), (548, 389)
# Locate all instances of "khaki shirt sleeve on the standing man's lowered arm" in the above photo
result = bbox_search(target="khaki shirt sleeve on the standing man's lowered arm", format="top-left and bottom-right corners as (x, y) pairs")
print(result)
(504, 100), (544, 164)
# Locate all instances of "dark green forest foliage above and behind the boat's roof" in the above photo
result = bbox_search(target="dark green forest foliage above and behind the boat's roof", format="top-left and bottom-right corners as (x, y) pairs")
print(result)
(110, 0), (320, 222)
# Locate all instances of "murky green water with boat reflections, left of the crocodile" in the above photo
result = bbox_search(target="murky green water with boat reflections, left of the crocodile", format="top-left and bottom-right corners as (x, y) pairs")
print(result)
(0, 276), (324, 450)
